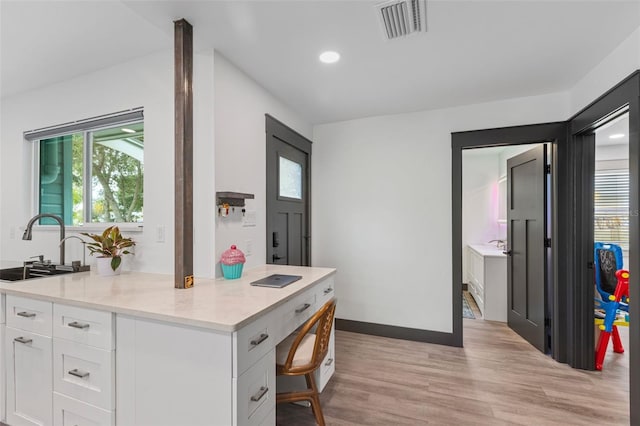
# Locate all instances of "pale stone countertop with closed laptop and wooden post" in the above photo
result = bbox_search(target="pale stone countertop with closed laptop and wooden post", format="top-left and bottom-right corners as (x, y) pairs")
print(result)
(0, 265), (335, 332)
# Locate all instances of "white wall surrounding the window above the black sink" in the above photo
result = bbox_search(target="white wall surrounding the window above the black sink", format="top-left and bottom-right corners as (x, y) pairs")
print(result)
(0, 50), (215, 276)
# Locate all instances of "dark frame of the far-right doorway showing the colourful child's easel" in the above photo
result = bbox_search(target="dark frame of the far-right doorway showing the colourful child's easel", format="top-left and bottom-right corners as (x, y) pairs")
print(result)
(567, 71), (640, 424)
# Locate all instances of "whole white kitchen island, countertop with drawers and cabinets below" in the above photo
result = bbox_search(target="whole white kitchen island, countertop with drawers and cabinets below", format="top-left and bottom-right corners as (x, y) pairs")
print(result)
(0, 265), (335, 426)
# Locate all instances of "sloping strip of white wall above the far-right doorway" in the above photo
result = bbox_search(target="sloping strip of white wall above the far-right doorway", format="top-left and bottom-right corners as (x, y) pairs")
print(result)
(566, 27), (640, 113)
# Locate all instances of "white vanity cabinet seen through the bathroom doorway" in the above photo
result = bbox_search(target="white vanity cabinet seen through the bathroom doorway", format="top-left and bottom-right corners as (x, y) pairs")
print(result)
(467, 244), (507, 322)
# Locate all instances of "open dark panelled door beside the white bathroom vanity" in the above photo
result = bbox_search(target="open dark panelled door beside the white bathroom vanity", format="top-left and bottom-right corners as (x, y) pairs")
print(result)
(507, 145), (547, 352)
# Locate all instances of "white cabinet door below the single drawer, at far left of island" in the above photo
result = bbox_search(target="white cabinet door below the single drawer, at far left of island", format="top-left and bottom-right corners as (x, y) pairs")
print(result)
(5, 327), (53, 426)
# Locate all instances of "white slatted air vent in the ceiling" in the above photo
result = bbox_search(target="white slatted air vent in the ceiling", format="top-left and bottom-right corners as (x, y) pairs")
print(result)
(376, 0), (427, 40)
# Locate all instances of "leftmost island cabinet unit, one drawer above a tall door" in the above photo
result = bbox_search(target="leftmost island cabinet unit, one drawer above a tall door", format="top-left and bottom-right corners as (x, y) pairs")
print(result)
(4, 295), (53, 426)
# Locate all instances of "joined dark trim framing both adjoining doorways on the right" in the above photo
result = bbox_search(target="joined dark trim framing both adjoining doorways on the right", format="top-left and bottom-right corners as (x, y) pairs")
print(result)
(451, 70), (640, 424)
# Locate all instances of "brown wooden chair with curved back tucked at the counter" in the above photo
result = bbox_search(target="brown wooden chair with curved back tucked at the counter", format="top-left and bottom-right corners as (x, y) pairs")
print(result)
(276, 299), (336, 426)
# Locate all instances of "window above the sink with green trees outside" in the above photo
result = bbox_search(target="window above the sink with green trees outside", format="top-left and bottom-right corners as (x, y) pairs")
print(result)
(25, 111), (144, 226)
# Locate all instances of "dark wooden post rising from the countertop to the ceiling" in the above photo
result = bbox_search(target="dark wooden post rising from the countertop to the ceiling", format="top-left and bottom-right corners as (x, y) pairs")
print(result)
(174, 19), (193, 288)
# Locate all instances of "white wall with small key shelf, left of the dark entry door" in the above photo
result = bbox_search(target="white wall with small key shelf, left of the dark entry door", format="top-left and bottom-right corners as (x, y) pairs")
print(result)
(213, 52), (312, 276)
